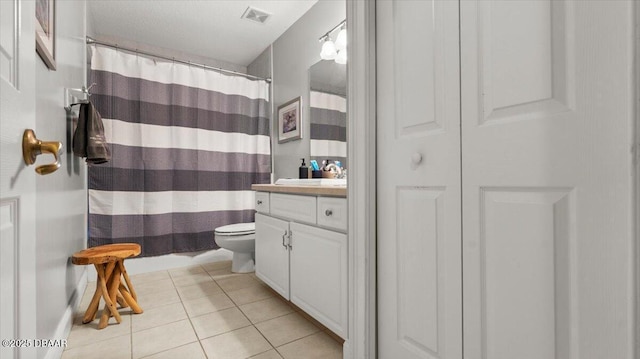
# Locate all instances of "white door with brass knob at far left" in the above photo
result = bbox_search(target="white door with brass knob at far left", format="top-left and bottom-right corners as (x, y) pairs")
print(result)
(0, 0), (37, 359)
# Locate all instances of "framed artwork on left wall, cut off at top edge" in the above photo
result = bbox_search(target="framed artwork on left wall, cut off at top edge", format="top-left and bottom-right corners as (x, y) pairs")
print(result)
(36, 0), (56, 70)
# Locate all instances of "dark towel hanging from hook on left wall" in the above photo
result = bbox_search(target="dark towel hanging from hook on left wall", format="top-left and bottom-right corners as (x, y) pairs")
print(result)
(73, 102), (111, 164)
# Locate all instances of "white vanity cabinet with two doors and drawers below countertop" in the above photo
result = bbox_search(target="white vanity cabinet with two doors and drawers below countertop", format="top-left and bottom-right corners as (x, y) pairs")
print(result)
(255, 192), (348, 338)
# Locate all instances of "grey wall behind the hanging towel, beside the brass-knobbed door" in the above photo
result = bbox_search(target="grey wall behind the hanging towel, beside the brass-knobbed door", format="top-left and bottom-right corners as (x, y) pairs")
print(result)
(35, 0), (87, 358)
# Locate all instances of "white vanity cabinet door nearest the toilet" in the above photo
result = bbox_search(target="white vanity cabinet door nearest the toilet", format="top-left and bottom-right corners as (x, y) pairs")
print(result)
(256, 213), (289, 299)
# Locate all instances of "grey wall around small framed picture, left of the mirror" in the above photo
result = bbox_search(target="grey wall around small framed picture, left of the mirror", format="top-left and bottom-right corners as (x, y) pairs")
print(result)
(271, 0), (346, 179)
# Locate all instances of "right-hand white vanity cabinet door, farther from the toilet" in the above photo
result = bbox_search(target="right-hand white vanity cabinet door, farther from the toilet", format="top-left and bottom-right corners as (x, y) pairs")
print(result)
(290, 223), (347, 338)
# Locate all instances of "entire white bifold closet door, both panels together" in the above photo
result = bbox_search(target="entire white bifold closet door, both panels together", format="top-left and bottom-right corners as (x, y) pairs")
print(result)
(376, 0), (637, 359)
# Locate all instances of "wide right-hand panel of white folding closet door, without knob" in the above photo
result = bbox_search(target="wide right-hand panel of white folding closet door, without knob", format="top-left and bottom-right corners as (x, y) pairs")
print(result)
(460, 0), (633, 359)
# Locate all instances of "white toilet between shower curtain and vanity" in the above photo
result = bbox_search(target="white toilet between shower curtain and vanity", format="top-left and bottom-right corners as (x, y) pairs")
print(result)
(215, 222), (256, 273)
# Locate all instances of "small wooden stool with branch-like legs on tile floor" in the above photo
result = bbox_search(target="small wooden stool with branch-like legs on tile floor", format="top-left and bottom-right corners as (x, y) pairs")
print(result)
(71, 243), (142, 329)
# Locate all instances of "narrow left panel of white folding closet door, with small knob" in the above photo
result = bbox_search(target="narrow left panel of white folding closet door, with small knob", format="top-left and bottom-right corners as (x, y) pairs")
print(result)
(376, 0), (462, 359)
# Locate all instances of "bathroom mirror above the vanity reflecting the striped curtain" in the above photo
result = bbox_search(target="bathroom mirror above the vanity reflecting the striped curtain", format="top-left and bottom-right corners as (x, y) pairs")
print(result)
(309, 60), (347, 168)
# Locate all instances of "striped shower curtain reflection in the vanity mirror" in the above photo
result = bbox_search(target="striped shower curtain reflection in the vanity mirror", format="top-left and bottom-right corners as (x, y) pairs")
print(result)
(309, 90), (347, 168)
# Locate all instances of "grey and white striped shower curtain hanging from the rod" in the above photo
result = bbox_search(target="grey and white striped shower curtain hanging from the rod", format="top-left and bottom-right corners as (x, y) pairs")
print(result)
(88, 46), (271, 256)
